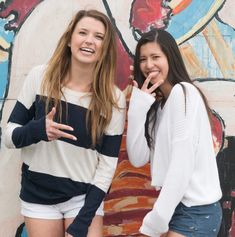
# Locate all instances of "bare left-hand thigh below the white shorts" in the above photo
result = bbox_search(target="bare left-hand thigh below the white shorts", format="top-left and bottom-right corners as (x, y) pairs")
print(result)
(24, 217), (64, 237)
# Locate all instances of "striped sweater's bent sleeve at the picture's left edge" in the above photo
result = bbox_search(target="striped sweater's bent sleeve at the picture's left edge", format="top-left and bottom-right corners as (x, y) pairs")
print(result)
(4, 66), (47, 148)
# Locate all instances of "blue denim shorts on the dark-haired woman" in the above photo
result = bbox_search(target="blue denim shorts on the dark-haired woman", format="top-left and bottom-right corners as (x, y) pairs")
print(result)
(169, 202), (222, 237)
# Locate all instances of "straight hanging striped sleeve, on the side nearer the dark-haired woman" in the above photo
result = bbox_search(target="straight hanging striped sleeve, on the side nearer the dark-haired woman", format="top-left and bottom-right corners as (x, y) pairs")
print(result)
(67, 87), (126, 237)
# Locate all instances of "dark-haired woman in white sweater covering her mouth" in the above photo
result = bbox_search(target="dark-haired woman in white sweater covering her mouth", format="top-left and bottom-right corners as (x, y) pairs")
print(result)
(127, 30), (222, 237)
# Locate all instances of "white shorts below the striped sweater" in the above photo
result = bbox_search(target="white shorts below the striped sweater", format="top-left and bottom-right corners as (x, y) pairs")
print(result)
(21, 195), (104, 219)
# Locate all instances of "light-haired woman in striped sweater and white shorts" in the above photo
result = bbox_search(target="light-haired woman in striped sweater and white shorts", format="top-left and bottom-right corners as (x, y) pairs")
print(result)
(5, 10), (126, 237)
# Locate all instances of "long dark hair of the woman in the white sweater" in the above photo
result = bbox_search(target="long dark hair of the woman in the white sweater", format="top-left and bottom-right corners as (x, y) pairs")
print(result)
(134, 29), (211, 148)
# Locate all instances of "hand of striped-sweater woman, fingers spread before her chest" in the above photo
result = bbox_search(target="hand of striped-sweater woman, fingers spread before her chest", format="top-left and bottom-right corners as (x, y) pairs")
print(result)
(46, 107), (77, 141)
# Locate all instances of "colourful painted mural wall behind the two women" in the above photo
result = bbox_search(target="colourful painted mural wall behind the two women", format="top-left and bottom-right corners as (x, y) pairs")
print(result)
(0, 0), (235, 237)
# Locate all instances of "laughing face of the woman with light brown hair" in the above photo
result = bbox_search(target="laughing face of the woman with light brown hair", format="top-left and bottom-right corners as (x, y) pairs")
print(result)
(70, 17), (105, 66)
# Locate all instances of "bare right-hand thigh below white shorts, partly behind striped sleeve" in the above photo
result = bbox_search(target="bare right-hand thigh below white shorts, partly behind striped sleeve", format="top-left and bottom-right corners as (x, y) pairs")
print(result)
(64, 215), (103, 237)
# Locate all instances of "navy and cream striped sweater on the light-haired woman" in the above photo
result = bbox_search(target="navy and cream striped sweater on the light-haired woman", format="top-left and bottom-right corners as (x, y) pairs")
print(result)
(4, 66), (126, 237)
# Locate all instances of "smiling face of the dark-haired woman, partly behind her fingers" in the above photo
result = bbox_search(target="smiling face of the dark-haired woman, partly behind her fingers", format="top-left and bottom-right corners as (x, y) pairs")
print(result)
(140, 42), (169, 84)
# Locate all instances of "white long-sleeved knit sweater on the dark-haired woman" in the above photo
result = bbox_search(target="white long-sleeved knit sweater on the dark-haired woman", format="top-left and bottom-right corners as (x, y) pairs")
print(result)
(127, 83), (222, 237)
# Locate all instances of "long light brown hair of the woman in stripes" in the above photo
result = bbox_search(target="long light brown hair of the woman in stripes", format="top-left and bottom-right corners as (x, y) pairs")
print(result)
(41, 10), (118, 146)
